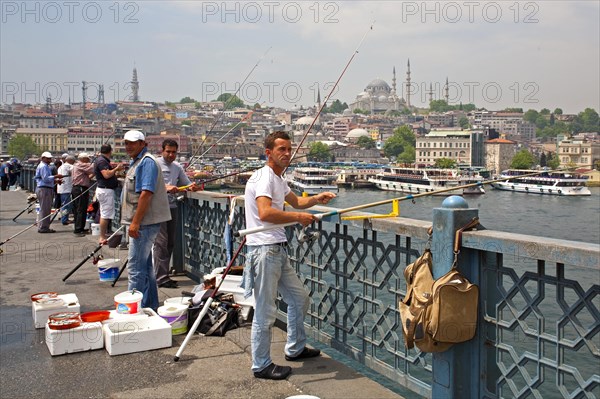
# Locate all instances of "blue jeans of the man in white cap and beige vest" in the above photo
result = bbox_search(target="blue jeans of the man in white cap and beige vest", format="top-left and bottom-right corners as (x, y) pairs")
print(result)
(127, 223), (160, 311)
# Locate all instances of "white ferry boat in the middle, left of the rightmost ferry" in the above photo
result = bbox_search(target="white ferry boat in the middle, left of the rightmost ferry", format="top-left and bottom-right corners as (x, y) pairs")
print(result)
(369, 167), (485, 195)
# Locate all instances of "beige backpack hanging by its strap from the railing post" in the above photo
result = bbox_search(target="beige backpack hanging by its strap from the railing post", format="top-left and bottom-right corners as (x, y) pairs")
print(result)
(399, 218), (479, 352)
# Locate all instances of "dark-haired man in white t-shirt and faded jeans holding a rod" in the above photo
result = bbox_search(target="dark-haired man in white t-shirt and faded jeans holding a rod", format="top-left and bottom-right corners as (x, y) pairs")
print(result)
(244, 132), (335, 380)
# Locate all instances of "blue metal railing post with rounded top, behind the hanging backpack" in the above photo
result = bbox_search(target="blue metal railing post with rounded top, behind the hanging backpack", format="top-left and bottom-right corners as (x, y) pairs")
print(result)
(432, 196), (482, 399)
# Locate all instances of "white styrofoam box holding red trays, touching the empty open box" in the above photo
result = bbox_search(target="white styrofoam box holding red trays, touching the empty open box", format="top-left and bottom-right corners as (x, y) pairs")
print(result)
(46, 322), (104, 356)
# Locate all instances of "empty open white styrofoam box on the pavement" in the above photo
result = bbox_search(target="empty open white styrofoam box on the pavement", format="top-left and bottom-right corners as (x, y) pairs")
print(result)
(102, 309), (173, 356)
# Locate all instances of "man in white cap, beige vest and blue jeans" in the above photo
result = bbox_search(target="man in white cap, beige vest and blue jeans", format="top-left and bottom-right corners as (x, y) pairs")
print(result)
(121, 130), (171, 310)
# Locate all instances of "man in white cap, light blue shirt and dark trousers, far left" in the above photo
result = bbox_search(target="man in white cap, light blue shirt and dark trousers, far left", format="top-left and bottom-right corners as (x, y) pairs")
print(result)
(34, 151), (63, 233)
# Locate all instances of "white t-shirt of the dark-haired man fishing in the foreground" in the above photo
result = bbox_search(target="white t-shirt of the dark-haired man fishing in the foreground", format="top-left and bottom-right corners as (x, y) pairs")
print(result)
(244, 166), (291, 245)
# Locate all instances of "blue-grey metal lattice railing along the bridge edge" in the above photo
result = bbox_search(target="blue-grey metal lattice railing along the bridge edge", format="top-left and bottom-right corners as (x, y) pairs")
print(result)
(181, 193), (600, 398)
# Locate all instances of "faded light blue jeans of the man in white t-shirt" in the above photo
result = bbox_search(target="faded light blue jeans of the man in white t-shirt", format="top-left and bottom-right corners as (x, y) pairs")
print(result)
(246, 245), (309, 372)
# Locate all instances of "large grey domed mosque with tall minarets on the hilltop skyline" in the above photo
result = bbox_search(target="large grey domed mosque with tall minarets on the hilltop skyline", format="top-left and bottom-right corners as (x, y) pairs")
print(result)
(349, 60), (410, 114)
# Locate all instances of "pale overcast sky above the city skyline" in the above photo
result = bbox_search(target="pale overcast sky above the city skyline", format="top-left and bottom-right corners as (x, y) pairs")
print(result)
(0, 0), (600, 113)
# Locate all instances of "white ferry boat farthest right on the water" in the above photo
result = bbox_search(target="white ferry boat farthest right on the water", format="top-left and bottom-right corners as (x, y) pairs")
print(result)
(492, 169), (592, 196)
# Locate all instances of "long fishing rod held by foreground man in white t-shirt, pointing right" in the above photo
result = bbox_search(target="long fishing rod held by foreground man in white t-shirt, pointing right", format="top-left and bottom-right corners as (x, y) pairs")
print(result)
(233, 168), (584, 237)
